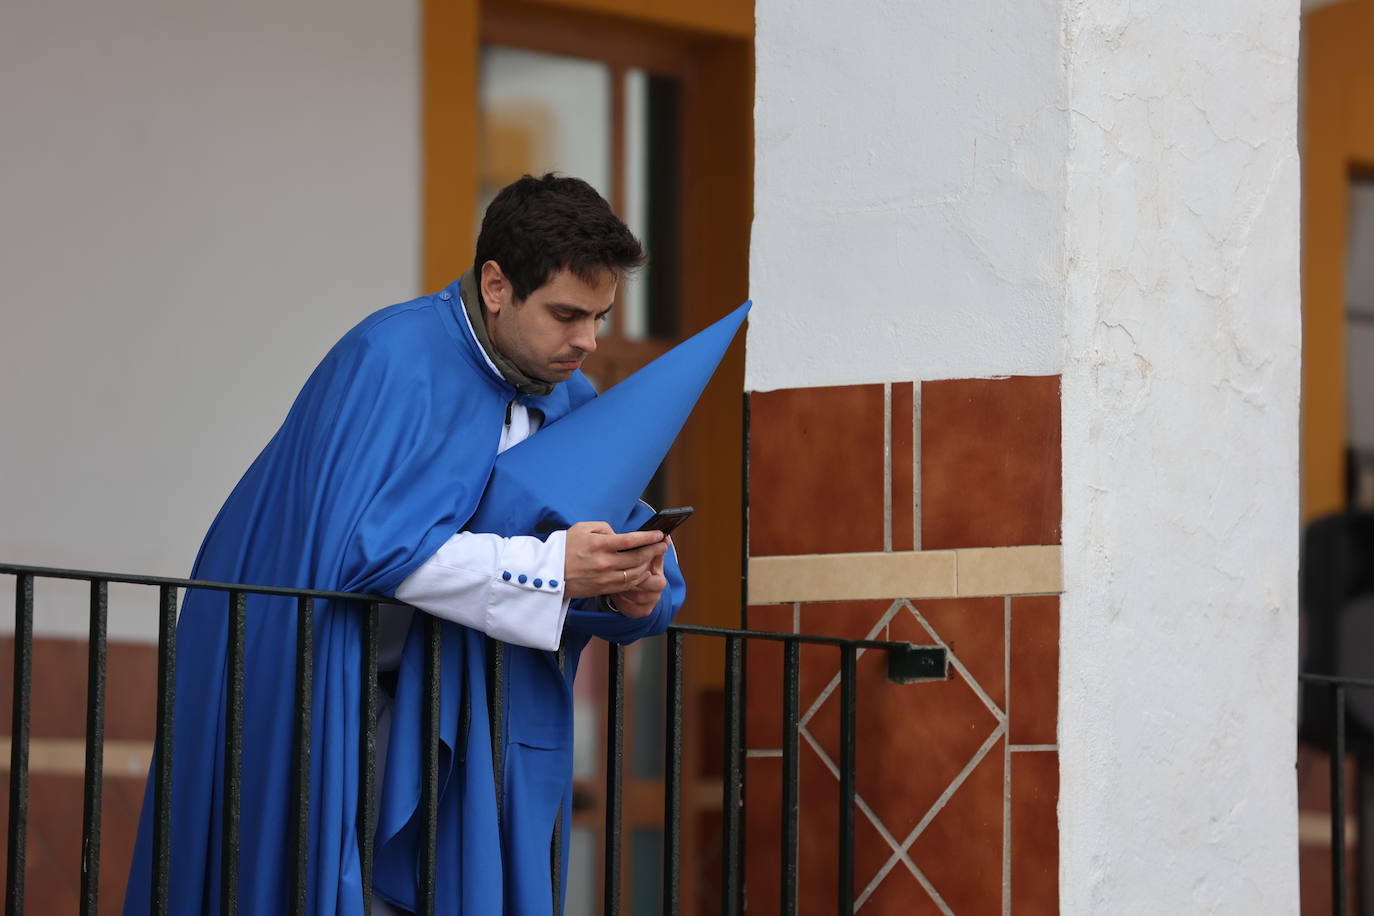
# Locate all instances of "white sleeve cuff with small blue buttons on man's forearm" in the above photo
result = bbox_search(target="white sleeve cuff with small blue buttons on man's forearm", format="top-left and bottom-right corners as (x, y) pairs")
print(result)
(396, 531), (570, 651)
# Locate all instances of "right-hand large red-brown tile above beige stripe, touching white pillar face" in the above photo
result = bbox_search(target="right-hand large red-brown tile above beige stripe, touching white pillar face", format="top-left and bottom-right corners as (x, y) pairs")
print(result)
(921, 375), (1062, 551)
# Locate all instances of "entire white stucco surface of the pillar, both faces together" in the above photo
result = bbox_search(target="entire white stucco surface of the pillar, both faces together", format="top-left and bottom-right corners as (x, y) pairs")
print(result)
(746, 0), (1300, 916)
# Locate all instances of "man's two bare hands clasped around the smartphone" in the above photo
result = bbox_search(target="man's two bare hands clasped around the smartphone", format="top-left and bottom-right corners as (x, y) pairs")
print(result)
(563, 522), (668, 617)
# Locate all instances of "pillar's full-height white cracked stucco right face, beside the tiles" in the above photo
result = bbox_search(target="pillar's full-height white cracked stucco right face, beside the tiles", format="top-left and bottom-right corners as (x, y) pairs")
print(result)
(1059, 0), (1301, 915)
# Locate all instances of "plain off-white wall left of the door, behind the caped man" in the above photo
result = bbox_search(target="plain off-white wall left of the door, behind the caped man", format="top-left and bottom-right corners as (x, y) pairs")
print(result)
(0, 0), (417, 637)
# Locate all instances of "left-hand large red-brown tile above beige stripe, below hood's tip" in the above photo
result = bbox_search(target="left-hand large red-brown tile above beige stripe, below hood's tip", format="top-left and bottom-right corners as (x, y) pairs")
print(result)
(749, 385), (883, 556)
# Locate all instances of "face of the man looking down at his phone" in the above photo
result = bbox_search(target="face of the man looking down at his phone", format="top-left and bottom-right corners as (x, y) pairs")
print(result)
(481, 261), (616, 382)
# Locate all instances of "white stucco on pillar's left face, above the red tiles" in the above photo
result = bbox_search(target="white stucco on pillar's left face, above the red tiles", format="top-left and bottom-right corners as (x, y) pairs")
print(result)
(745, 0), (1069, 390)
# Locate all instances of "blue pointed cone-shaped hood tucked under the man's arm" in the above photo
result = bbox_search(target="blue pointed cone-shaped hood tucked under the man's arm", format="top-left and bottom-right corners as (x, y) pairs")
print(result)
(467, 302), (752, 537)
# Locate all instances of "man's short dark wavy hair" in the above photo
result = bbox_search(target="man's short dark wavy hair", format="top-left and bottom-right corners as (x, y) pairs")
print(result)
(473, 172), (644, 299)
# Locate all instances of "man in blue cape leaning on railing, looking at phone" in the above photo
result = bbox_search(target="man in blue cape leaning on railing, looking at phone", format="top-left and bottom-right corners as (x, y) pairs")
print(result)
(125, 176), (684, 915)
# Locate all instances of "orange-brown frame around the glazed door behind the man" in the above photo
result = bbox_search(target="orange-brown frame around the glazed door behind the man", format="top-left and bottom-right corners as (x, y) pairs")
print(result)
(420, 0), (753, 912)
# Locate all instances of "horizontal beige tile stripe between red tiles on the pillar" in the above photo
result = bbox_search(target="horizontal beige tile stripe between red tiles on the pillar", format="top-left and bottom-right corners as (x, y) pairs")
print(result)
(749, 545), (1063, 604)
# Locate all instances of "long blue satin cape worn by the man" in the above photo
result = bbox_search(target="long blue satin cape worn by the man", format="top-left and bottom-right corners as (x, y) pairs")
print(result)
(125, 283), (684, 916)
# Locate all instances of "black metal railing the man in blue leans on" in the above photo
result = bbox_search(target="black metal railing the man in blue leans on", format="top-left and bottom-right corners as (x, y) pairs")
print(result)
(0, 564), (945, 916)
